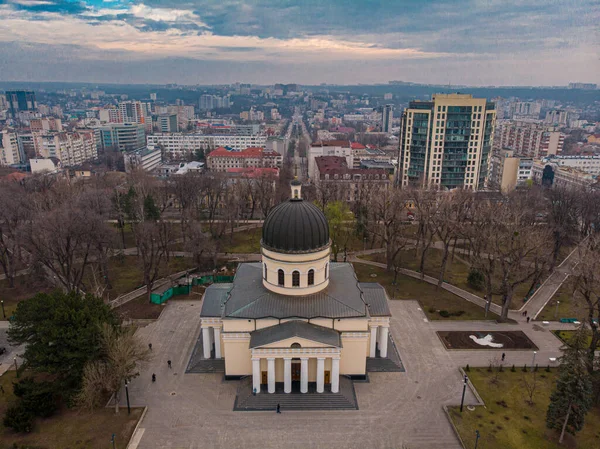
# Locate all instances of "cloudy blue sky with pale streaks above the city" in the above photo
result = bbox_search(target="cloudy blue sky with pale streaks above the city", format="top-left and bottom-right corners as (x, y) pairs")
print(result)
(0, 0), (600, 86)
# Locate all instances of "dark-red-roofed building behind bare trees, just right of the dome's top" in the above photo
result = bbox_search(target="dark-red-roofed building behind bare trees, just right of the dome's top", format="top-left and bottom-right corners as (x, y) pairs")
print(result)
(313, 156), (392, 202)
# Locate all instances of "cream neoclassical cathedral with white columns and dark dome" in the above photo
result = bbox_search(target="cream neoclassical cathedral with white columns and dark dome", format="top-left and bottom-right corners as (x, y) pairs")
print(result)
(201, 180), (393, 394)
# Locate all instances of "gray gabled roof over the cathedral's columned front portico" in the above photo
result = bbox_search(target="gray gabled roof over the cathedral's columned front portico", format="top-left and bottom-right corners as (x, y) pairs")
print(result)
(250, 320), (342, 348)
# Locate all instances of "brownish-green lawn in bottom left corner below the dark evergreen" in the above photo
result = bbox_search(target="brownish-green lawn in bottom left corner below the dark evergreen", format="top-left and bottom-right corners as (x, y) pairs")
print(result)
(0, 370), (143, 449)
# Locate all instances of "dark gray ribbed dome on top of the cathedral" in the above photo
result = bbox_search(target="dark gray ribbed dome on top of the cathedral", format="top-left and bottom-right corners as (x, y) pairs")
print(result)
(261, 199), (329, 253)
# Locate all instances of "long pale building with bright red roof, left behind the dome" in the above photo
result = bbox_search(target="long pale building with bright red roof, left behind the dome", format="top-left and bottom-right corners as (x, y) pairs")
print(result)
(206, 147), (283, 172)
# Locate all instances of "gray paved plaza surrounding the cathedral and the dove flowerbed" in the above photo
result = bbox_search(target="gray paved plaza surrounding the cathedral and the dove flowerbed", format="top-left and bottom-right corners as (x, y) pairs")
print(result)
(123, 292), (560, 449)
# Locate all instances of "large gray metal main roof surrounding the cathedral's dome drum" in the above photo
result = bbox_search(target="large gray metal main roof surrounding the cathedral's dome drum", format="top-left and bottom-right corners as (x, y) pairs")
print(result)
(223, 263), (368, 319)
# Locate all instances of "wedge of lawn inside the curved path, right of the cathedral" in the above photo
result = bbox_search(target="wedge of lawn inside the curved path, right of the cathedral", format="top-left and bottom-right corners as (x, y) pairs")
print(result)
(354, 263), (498, 320)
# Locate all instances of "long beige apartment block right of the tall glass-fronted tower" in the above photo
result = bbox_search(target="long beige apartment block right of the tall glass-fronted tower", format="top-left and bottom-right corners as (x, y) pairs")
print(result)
(494, 121), (565, 158)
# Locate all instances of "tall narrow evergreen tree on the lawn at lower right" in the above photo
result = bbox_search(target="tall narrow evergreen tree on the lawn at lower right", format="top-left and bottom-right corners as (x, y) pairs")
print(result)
(546, 326), (592, 443)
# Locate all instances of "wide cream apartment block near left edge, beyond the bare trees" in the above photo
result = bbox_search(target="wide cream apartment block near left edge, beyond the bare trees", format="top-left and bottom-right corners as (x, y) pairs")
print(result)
(34, 130), (98, 167)
